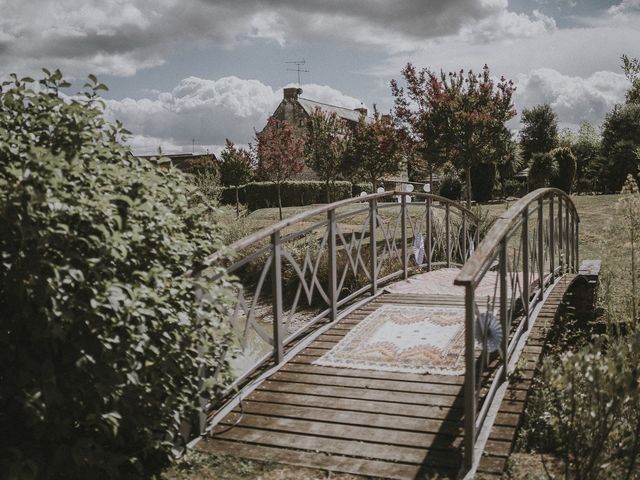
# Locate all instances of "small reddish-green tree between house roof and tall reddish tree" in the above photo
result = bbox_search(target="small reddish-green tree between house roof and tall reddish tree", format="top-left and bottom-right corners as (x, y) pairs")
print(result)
(344, 112), (404, 192)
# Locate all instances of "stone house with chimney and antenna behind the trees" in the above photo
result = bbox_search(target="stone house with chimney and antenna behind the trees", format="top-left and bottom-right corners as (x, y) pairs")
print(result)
(267, 87), (407, 181)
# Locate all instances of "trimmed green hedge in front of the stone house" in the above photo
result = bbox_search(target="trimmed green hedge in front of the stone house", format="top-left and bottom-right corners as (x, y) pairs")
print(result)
(221, 181), (350, 210)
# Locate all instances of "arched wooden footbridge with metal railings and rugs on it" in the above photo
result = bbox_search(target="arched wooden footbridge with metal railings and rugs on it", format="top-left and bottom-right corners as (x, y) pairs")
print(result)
(194, 189), (579, 479)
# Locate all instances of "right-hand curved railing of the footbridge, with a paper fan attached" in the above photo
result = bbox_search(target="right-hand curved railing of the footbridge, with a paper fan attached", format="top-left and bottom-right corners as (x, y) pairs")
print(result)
(455, 188), (579, 469)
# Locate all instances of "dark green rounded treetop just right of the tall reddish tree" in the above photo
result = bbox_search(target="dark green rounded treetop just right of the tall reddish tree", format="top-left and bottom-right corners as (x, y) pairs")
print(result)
(520, 103), (559, 164)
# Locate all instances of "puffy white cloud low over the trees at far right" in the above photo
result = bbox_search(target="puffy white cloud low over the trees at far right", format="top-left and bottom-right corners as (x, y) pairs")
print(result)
(514, 68), (629, 128)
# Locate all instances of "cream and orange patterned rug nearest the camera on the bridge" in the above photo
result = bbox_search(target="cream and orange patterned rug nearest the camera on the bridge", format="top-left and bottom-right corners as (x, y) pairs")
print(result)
(313, 305), (464, 375)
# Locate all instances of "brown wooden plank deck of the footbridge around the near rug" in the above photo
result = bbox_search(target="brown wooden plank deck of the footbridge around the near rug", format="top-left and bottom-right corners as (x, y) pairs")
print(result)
(198, 274), (570, 479)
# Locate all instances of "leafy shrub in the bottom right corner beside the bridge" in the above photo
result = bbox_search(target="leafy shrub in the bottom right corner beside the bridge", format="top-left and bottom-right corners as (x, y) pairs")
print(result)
(533, 331), (640, 479)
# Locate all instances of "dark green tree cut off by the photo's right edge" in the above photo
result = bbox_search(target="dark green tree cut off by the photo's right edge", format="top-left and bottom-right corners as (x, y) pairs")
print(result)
(602, 103), (640, 192)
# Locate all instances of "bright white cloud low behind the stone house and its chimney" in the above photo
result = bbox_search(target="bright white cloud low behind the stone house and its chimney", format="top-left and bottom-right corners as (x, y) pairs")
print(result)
(106, 77), (360, 153)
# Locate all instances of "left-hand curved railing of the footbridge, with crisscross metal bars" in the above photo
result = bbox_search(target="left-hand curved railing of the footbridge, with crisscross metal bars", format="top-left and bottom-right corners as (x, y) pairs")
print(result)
(199, 191), (478, 406)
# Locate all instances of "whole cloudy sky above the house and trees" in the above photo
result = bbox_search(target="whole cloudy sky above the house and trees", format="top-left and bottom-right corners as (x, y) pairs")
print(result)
(0, 0), (640, 152)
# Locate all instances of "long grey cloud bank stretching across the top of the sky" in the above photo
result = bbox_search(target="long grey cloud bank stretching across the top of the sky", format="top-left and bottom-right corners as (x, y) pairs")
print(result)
(0, 0), (555, 77)
